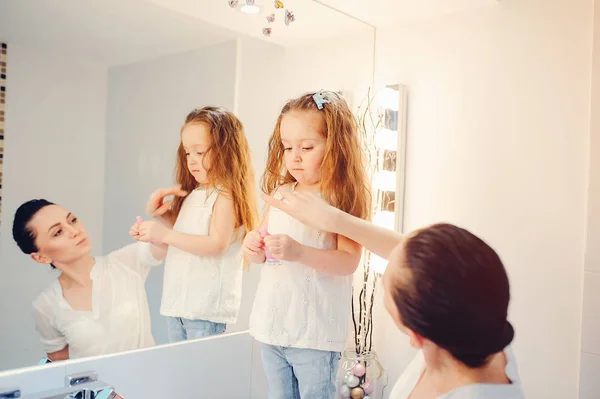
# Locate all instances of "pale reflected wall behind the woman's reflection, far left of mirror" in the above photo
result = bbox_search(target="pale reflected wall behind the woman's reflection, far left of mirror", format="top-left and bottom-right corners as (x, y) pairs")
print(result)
(0, 43), (106, 370)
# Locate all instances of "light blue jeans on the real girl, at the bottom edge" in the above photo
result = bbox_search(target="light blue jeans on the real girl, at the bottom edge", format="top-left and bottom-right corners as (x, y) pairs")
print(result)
(261, 344), (340, 399)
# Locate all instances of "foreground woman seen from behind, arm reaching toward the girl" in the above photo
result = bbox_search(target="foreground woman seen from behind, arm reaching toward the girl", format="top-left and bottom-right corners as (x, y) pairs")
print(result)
(264, 191), (524, 399)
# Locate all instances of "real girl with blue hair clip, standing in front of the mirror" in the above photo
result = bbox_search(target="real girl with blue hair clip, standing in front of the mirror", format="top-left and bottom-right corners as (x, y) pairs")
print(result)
(244, 92), (370, 399)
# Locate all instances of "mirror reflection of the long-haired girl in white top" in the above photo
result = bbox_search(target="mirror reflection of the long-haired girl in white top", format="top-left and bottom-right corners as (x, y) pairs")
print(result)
(132, 107), (257, 342)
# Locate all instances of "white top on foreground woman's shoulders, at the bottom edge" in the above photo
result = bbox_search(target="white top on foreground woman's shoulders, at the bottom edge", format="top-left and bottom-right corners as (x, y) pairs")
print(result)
(389, 346), (524, 399)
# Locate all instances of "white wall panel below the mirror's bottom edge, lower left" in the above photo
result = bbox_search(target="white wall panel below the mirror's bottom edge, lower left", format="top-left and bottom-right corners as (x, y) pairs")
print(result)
(0, 333), (252, 399)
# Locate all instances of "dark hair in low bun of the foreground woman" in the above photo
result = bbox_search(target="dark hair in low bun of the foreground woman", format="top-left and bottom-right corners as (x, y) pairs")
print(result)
(393, 224), (514, 368)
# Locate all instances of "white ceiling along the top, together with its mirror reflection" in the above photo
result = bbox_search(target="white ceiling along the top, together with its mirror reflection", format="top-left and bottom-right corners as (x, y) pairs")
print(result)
(0, 0), (497, 67)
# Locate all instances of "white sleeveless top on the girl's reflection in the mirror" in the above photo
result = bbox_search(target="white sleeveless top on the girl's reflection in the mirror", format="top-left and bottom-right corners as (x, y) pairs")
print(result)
(160, 189), (243, 323)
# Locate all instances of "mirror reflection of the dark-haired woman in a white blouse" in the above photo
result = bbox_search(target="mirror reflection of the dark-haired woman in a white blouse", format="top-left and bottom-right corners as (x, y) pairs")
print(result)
(13, 199), (160, 361)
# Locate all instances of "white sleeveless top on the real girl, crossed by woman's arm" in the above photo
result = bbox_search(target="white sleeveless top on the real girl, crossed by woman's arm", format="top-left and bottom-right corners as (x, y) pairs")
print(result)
(250, 186), (352, 352)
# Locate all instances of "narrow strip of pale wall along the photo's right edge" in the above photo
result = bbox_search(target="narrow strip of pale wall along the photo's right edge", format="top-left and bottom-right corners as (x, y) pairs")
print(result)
(579, 3), (600, 399)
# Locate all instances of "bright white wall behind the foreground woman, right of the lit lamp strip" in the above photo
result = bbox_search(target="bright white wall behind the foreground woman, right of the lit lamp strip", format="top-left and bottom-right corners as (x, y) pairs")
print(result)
(375, 0), (600, 399)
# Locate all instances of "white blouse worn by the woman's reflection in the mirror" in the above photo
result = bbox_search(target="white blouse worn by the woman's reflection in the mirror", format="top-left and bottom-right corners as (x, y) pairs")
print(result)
(33, 243), (160, 359)
